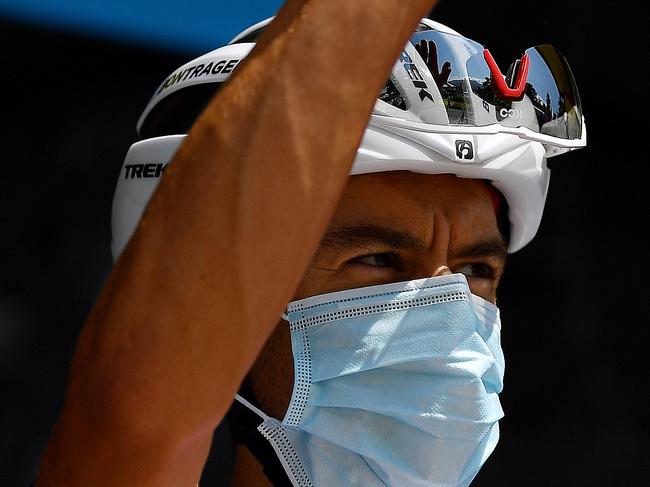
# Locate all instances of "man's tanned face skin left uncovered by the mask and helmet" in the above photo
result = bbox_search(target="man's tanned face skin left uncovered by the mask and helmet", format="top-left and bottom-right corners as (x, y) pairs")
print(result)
(249, 171), (506, 419)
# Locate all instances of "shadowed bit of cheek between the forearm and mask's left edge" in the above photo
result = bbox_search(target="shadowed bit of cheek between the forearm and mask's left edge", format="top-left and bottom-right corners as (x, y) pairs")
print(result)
(248, 320), (293, 420)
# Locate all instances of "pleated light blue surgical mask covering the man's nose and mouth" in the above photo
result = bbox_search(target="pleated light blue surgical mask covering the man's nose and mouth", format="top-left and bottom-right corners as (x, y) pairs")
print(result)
(237, 274), (504, 487)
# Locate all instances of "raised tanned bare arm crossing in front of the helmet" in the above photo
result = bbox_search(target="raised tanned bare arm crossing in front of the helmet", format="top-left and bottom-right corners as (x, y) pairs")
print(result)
(37, 0), (433, 487)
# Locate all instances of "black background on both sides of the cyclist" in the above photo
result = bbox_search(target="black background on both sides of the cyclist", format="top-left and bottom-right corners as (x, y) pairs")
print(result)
(0, 0), (650, 486)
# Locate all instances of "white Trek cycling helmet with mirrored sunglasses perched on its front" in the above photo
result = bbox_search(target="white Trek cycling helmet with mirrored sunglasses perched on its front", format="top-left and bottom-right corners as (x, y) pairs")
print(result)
(111, 18), (586, 259)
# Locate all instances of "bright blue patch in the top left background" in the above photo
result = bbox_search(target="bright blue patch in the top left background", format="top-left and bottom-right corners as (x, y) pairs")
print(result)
(0, 0), (284, 55)
